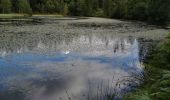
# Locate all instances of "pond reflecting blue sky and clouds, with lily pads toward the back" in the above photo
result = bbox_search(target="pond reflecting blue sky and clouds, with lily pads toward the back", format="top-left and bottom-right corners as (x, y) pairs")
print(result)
(0, 19), (166, 100)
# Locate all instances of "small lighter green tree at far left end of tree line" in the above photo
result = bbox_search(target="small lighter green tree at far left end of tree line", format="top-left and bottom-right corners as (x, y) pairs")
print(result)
(0, 0), (12, 13)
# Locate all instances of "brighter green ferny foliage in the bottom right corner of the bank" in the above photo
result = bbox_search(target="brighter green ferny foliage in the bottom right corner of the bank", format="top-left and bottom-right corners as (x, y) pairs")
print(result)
(124, 68), (170, 100)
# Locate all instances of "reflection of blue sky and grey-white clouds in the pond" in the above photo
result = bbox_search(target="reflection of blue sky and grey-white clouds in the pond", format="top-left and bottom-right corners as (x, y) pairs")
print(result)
(0, 35), (142, 100)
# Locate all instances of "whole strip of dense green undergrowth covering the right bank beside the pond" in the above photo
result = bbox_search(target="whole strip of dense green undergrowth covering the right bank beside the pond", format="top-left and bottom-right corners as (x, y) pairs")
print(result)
(124, 36), (170, 100)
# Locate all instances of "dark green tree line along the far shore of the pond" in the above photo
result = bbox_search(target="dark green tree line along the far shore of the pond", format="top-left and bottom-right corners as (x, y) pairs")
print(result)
(0, 0), (170, 23)
